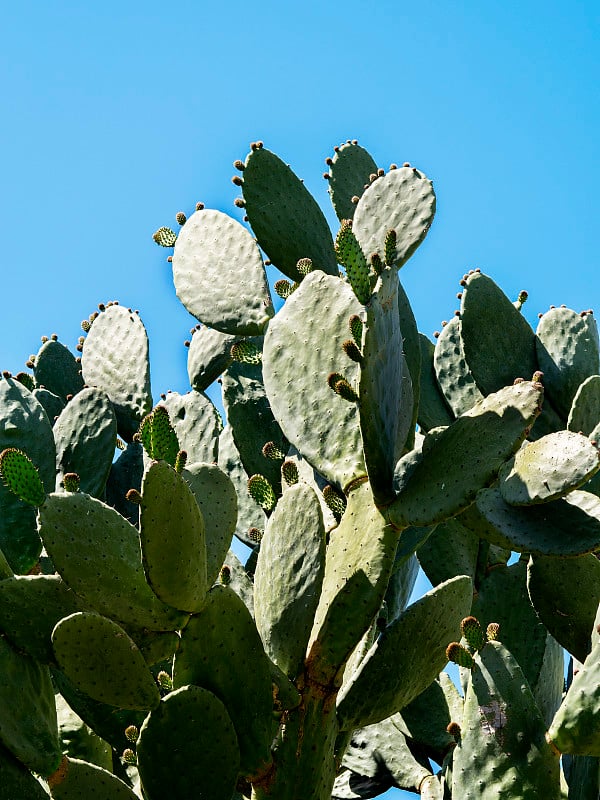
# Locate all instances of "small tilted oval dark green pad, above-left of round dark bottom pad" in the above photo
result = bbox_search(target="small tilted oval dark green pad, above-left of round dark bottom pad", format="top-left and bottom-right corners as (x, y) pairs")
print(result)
(52, 612), (160, 710)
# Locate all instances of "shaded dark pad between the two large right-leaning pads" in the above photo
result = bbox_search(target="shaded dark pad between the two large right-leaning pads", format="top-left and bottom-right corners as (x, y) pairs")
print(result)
(417, 519), (479, 586)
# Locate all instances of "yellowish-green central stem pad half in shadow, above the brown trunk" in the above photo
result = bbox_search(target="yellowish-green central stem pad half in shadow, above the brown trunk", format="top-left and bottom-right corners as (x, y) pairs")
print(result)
(307, 483), (398, 685)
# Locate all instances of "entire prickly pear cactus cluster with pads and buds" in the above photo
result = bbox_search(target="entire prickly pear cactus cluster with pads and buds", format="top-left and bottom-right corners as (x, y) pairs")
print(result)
(0, 140), (600, 800)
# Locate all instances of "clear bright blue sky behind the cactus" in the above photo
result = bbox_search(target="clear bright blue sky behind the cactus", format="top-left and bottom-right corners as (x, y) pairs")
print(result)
(0, 0), (600, 797)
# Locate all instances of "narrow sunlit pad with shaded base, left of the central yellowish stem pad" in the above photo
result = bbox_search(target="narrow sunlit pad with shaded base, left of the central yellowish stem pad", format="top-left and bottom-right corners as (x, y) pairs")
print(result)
(255, 483), (325, 678)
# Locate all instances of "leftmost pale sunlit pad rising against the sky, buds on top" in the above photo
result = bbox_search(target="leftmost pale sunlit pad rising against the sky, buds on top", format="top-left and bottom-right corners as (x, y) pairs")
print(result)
(81, 305), (152, 442)
